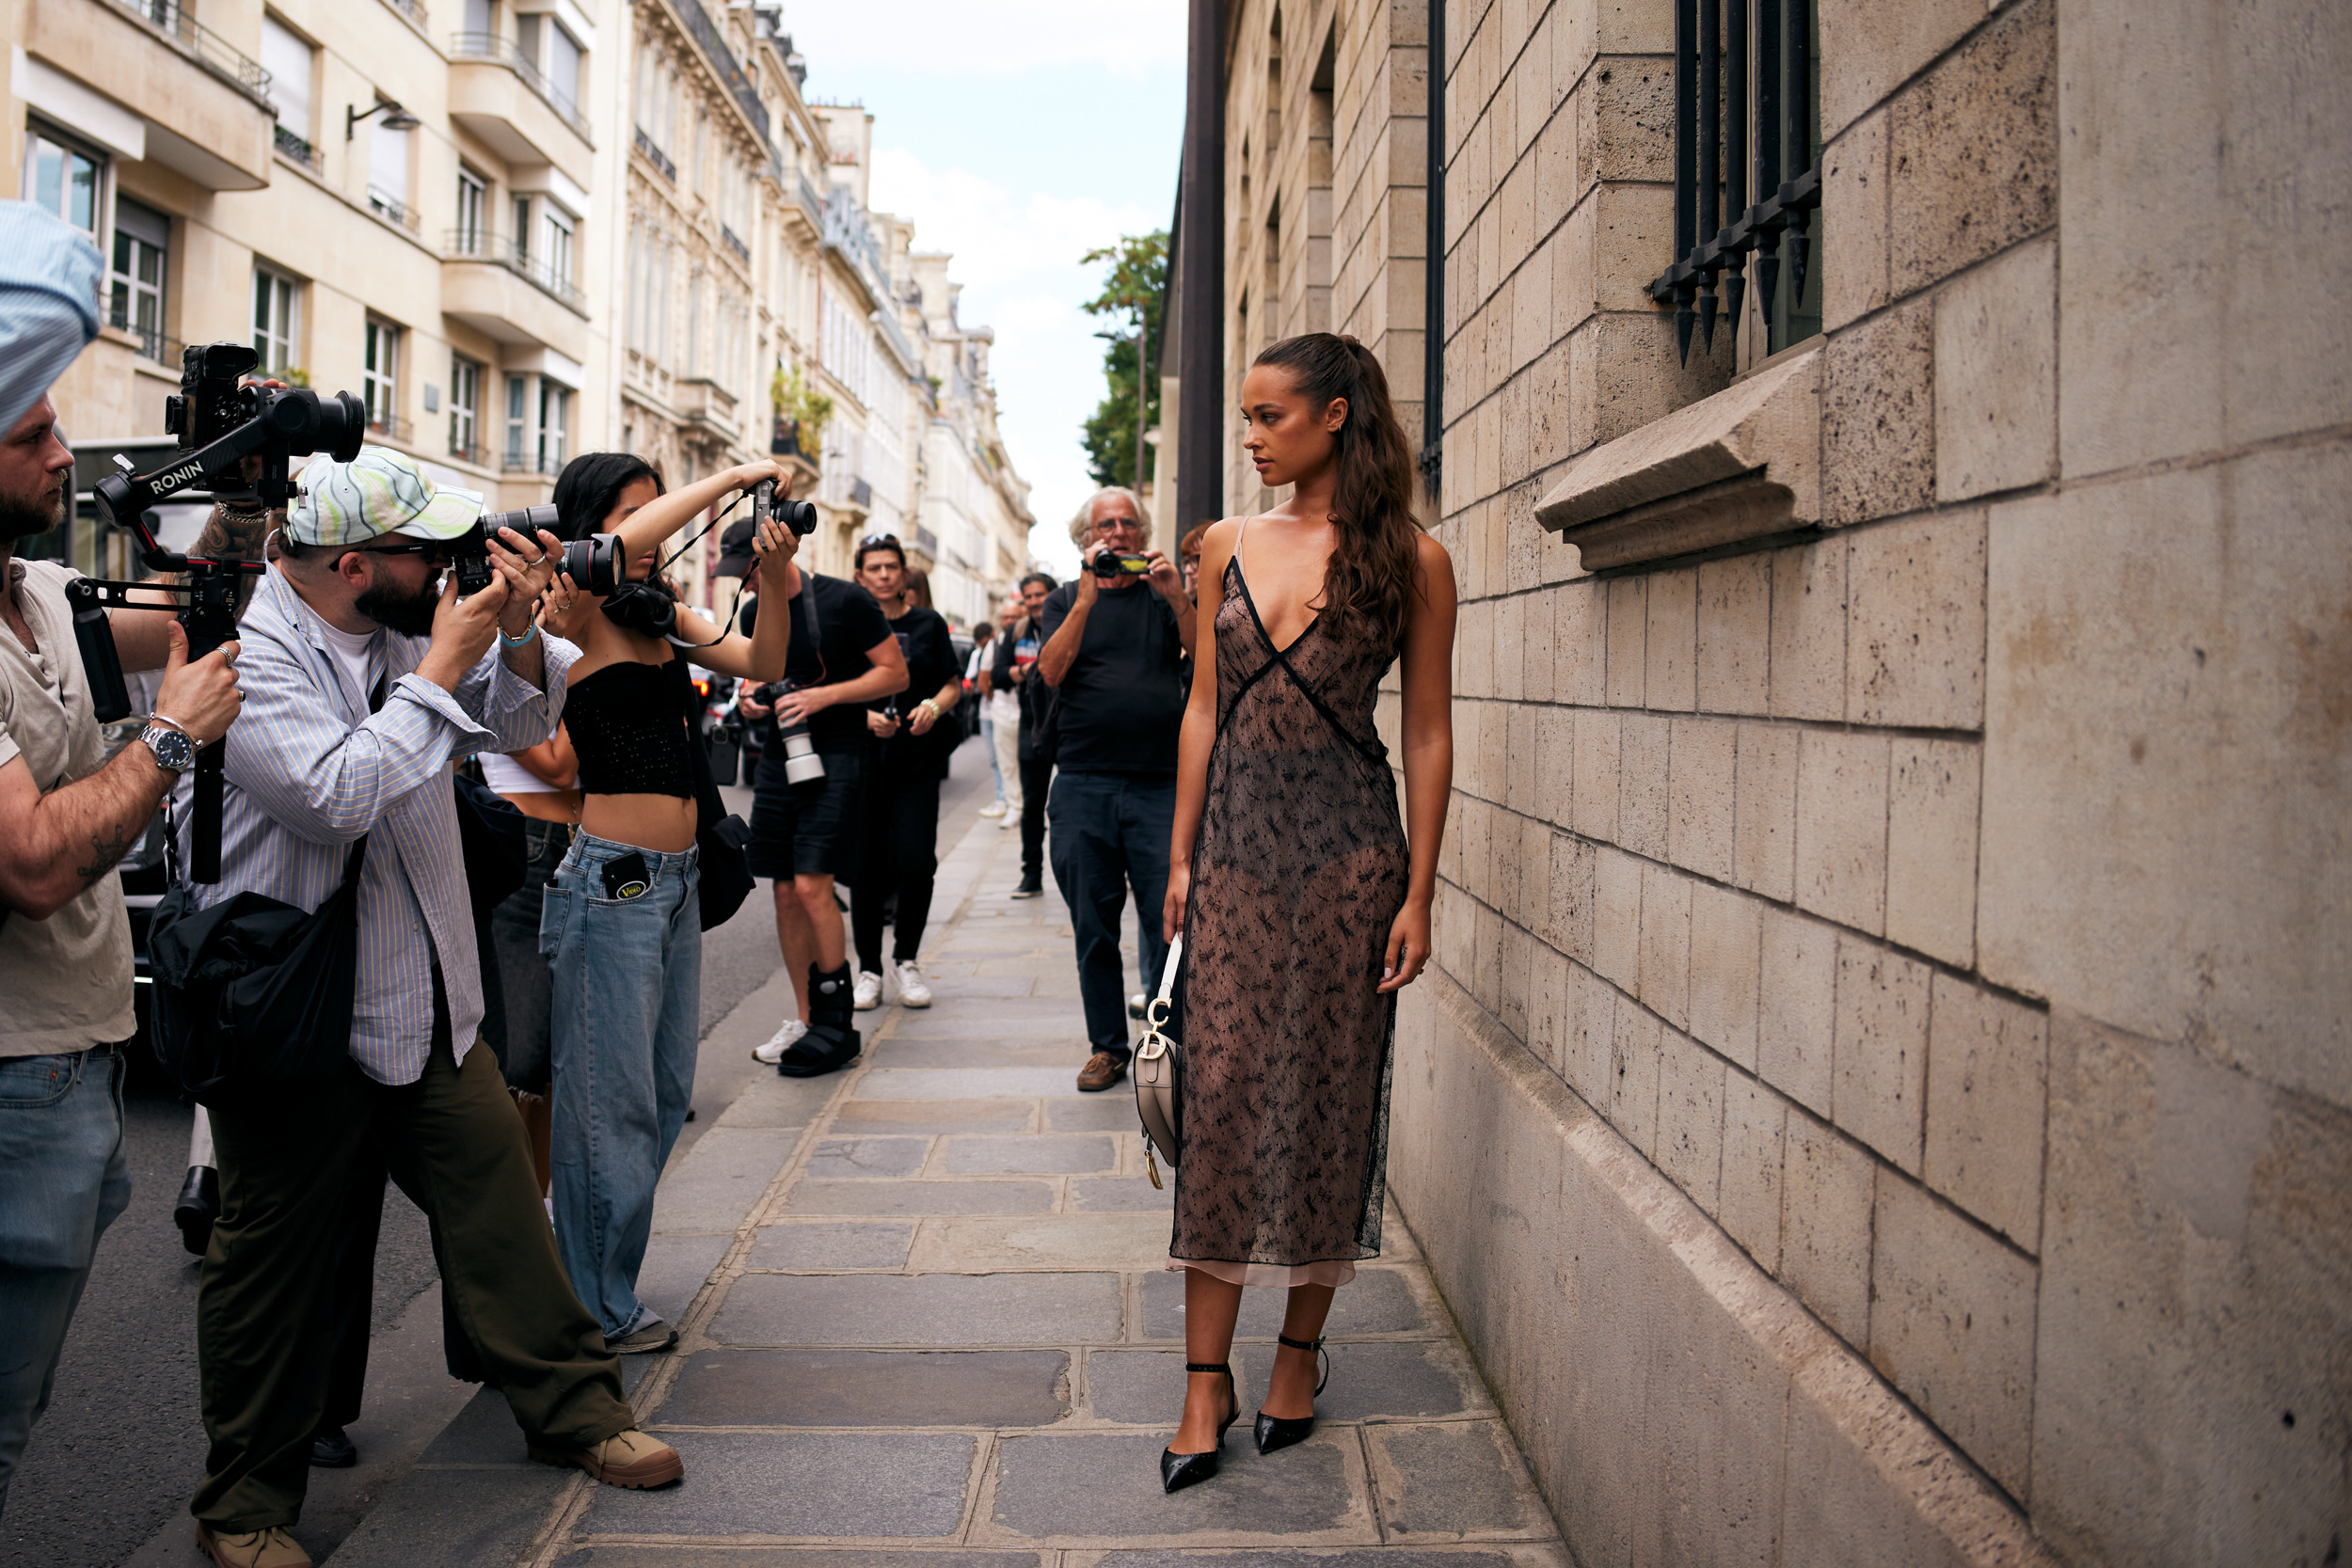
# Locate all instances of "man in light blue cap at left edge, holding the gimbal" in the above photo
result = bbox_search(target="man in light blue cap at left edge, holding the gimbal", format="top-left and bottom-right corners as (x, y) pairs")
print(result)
(0, 202), (238, 1507)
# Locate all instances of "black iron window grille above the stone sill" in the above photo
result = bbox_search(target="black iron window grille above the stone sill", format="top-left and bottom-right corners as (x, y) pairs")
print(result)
(1649, 0), (1820, 359)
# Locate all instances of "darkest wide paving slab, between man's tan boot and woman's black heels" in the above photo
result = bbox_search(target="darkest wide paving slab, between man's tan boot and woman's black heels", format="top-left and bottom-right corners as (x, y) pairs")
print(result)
(661, 1350), (1071, 1430)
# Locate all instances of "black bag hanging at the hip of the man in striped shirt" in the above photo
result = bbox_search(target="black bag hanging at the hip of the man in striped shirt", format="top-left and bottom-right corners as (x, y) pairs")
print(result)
(149, 837), (367, 1105)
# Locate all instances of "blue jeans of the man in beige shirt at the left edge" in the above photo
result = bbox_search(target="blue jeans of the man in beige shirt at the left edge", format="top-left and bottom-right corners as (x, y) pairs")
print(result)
(0, 1048), (132, 1510)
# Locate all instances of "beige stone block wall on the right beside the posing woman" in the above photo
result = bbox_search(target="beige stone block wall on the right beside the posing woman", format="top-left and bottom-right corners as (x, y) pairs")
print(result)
(1171, 0), (2352, 1566)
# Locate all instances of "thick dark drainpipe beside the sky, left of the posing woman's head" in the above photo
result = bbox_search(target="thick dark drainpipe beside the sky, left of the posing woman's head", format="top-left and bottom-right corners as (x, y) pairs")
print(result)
(1162, 0), (1226, 541)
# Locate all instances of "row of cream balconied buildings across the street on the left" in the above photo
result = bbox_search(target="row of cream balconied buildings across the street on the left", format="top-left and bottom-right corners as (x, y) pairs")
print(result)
(16, 0), (1028, 623)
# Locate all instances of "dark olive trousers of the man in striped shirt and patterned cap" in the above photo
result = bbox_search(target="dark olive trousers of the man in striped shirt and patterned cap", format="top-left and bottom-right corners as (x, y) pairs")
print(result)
(188, 1025), (638, 1530)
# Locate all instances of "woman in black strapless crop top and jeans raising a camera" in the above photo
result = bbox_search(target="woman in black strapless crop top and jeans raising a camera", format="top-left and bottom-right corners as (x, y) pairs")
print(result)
(539, 451), (800, 1352)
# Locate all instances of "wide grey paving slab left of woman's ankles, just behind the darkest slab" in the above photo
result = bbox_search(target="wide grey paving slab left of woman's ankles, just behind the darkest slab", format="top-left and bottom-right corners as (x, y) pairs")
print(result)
(710, 1275), (1122, 1345)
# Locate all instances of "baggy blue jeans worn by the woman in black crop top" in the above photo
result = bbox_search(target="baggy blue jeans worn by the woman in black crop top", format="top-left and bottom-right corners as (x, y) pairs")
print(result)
(539, 832), (704, 1340)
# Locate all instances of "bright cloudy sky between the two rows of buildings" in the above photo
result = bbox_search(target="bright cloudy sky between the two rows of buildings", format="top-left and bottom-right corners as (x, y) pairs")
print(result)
(784, 0), (1185, 571)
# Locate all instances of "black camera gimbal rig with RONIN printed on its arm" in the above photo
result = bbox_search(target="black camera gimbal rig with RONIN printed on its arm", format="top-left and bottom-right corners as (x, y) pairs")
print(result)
(66, 343), (367, 881)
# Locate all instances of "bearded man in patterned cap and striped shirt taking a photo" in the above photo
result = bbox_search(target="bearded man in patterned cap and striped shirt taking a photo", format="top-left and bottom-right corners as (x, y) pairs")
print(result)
(191, 447), (685, 1568)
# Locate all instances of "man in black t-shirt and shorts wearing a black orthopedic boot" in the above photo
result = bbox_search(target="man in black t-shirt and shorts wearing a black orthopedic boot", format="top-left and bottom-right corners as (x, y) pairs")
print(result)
(720, 526), (908, 1079)
